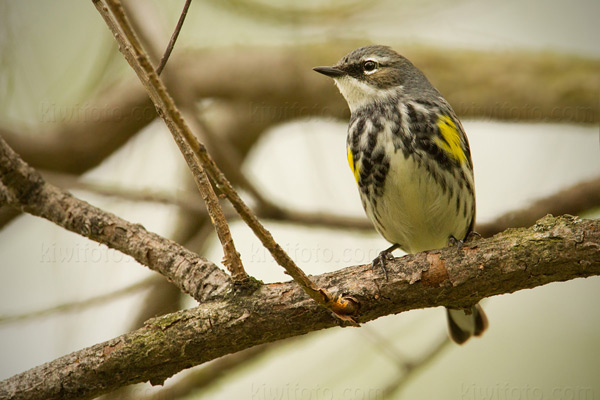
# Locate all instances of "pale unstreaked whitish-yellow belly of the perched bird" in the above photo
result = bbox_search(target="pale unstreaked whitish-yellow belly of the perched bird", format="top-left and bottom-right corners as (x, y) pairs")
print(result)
(361, 154), (474, 253)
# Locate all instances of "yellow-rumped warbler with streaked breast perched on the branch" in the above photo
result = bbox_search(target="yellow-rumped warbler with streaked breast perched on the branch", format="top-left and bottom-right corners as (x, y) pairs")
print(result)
(314, 46), (487, 343)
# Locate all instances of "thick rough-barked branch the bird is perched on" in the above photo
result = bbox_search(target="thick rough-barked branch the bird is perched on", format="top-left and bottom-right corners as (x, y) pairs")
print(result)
(0, 216), (600, 399)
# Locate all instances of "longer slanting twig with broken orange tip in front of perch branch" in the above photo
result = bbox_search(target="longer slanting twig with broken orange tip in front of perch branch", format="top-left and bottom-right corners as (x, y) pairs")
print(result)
(92, 0), (342, 316)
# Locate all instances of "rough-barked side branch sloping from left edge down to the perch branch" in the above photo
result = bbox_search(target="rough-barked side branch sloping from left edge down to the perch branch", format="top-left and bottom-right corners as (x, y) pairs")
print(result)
(0, 138), (230, 301)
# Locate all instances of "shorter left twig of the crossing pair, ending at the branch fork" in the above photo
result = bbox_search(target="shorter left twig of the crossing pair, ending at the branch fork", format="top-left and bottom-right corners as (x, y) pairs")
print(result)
(92, 0), (247, 280)
